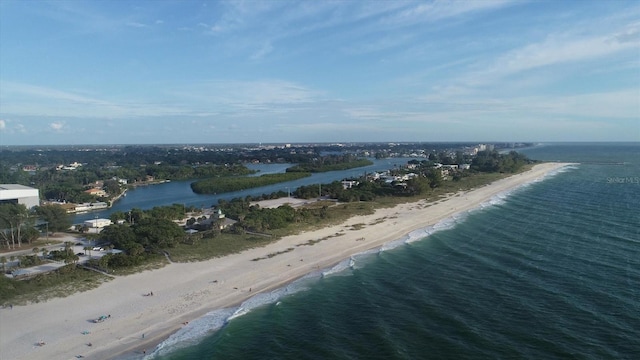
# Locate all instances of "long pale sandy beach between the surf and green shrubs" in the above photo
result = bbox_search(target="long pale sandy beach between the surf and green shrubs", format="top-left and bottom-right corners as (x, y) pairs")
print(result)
(0, 163), (567, 360)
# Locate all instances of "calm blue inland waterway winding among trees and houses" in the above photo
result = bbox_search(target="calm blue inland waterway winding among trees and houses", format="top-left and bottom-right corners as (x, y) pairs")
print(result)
(73, 158), (412, 224)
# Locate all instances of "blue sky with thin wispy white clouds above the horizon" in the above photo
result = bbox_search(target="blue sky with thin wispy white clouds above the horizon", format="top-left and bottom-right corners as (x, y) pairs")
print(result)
(0, 0), (640, 145)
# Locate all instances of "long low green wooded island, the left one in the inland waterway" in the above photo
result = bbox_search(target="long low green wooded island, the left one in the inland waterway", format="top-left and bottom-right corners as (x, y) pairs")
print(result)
(191, 172), (311, 194)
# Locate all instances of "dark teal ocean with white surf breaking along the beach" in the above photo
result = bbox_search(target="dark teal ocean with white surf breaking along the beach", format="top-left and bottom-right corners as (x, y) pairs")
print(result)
(147, 143), (640, 360)
